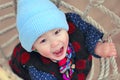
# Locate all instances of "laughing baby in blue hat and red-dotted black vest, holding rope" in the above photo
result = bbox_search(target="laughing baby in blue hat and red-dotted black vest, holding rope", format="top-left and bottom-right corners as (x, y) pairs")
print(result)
(10, 0), (117, 80)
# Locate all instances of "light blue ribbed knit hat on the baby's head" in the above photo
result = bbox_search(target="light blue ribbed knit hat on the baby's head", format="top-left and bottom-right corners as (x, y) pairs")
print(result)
(17, 0), (68, 52)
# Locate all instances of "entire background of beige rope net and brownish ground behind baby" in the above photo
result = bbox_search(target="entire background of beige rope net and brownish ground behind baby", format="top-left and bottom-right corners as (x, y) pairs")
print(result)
(0, 0), (120, 80)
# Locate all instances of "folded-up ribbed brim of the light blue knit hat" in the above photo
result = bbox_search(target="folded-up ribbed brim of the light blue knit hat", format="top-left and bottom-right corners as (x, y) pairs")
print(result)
(17, 9), (68, 52)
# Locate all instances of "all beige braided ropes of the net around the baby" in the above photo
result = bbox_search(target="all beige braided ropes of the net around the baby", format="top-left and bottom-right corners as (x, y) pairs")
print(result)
(0, 0), (120, 80)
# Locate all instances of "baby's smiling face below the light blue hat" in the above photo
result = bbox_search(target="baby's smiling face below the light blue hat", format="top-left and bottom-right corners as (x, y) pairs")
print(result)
(33, 29), (69, 60)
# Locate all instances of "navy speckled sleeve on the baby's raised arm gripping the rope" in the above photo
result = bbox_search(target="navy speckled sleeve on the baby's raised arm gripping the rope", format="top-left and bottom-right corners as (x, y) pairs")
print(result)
(66, 13), (103, 58)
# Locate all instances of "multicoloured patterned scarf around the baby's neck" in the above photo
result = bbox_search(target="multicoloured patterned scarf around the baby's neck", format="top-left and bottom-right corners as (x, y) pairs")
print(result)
(58, 43), (75, 80)
